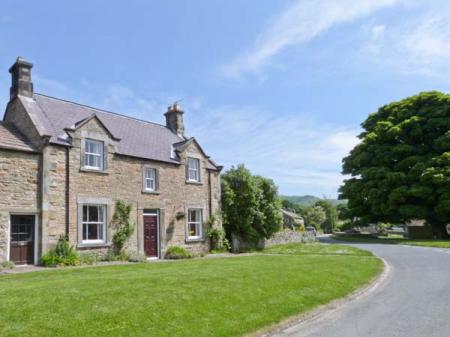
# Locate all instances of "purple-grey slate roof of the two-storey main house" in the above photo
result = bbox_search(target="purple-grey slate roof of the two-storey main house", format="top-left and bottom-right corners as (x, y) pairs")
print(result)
(20, 93), (209, 164)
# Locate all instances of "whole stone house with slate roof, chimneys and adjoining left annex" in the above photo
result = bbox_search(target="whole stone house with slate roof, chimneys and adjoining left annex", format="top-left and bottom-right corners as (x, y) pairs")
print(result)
(0, 58), (222, 264)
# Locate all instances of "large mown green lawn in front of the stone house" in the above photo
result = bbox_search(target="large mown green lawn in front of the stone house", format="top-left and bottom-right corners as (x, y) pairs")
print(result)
(0, 244), (382, 337)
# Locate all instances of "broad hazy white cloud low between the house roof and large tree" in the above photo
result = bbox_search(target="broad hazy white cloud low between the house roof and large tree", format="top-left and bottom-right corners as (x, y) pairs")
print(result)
(185, 100), (360, 197)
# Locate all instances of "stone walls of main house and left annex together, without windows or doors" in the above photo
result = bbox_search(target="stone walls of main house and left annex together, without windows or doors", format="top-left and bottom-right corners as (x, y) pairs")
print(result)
(0, 115), (220, 259)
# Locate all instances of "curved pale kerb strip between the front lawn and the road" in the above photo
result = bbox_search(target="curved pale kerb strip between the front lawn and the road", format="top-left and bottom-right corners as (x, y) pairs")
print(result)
(247, 254), (392, 337)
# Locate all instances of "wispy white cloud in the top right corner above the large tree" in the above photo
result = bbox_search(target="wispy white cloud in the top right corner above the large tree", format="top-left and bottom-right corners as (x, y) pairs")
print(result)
(360, 7), (450, 82)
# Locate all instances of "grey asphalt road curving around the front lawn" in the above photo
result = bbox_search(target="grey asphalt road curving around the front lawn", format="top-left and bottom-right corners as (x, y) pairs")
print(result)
(273, 236), (450, 337)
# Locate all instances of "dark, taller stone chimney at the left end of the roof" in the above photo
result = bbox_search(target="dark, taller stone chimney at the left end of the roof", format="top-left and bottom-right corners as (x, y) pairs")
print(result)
(9, 57), (33, 100)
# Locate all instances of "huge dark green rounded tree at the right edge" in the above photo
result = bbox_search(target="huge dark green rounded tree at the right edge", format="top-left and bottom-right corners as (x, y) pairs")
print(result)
(340, 92), (450, 233)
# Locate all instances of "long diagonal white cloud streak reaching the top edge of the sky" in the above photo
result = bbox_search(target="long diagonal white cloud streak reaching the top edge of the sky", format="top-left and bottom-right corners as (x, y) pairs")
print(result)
(221, 0), (403, 79)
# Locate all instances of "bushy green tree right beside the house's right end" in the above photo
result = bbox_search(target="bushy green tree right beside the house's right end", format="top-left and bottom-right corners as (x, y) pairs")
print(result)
(221, 165), (282, 243)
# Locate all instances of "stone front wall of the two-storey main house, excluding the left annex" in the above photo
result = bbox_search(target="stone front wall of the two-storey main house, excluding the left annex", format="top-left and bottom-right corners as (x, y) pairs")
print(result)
(56, 115), (220, 256)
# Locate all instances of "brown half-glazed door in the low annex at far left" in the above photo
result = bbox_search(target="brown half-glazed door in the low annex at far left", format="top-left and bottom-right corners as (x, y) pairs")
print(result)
(9, 215), (35, 264)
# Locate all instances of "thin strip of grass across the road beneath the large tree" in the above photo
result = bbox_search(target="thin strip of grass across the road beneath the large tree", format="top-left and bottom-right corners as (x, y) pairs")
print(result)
(334, 235), (450, 248)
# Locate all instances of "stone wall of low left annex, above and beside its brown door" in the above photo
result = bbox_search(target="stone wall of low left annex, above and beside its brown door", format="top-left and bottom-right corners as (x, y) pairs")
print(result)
(0, 149), (40, 262)
